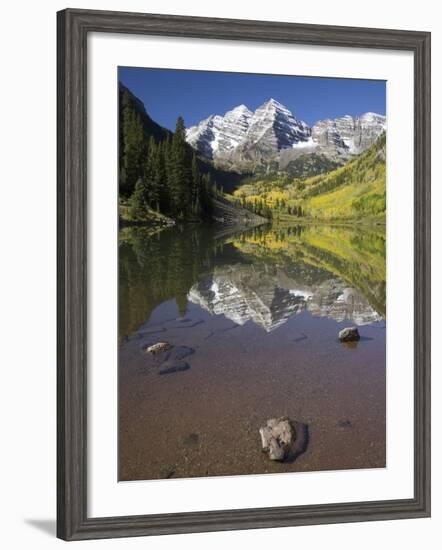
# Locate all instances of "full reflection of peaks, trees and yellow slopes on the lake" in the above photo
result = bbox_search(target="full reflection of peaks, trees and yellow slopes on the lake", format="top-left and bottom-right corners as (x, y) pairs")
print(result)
(119, 225), (385, 338)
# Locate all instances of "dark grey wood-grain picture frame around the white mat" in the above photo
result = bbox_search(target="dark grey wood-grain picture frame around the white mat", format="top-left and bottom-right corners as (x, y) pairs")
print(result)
(57, 9), (430, 540)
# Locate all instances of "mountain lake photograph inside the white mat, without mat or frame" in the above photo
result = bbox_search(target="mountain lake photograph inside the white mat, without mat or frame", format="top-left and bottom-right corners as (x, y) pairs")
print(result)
(117, 66), (387, 481)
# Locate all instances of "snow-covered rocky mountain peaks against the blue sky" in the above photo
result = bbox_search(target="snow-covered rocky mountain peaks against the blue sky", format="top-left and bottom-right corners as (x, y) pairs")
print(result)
(186, 99), (386, 170)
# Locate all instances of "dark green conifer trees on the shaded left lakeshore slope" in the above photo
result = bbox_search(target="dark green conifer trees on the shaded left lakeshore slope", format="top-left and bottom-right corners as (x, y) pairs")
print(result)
(119, 90), (215, 221)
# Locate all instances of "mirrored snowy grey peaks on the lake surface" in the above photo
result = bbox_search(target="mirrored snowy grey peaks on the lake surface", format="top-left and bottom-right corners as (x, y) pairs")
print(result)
(188, 264), (382, 332)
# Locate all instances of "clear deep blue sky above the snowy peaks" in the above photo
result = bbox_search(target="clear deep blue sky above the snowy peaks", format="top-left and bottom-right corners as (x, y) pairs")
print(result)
(119, 67), (386, 130)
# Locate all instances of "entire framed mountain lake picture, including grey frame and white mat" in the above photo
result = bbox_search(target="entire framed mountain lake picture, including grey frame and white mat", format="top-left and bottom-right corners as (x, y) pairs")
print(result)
(57, 9), (430, 540)
